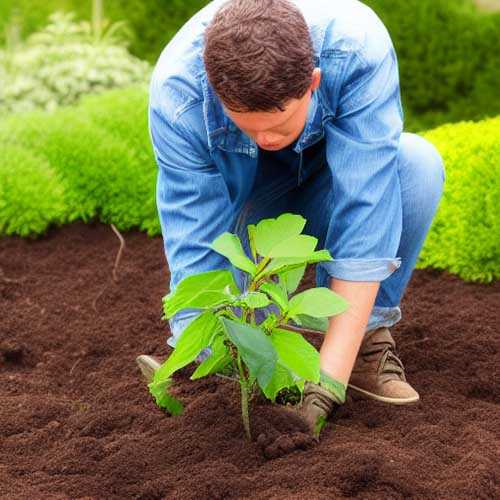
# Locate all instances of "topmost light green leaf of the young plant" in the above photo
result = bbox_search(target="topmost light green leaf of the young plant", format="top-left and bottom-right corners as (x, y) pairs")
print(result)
(255, 214), (306, 257)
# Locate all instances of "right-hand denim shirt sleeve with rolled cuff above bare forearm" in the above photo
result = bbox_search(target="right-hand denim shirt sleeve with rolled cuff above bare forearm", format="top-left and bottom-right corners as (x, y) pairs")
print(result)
(321, 35), (403, 281)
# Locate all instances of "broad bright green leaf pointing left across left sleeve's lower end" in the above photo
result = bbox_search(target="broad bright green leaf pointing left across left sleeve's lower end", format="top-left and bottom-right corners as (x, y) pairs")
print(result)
(163, 269), (239, 319)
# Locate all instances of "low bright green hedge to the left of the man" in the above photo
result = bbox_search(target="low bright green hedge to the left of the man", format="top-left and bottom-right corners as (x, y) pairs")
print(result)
(0, 87), (160, 236)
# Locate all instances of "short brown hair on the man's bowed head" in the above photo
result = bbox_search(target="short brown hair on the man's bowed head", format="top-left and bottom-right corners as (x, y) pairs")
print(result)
(203, 0), (314, 112)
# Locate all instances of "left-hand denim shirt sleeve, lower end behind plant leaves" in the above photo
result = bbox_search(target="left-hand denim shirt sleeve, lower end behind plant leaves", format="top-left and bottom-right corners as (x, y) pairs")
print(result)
(149, 105), (233, 345)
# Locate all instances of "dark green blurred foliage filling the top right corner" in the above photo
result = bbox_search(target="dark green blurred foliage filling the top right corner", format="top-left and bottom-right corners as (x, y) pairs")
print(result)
(365, 0), (500, 130)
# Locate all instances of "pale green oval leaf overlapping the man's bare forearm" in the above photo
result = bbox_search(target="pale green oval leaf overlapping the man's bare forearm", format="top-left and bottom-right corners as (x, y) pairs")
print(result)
(288, 287), (349, 318)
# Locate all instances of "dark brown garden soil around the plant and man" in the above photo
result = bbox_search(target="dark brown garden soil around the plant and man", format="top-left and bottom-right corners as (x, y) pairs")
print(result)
(0, 224), (500, 499)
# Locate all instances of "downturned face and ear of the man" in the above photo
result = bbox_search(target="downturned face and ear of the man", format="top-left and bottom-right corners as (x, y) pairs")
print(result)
(224, 68), (321, 151)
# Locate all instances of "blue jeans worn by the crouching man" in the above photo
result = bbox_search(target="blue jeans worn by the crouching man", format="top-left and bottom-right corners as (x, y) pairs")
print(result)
(233, 133), (445, 331)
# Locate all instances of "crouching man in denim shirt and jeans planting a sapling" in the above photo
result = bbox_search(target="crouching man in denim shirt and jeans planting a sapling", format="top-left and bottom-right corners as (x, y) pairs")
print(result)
(138, 0), (444, 434)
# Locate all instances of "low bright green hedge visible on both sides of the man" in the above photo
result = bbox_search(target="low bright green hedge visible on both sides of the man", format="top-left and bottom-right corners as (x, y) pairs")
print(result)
(0, 88), (500, 282)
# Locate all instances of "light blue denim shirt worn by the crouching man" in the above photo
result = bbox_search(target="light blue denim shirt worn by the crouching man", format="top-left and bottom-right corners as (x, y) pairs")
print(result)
(149, 0), (403, 337)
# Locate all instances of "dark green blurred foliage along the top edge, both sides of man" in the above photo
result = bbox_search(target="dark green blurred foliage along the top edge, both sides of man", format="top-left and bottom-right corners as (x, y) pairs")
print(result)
(0, 0), (500, 131)
